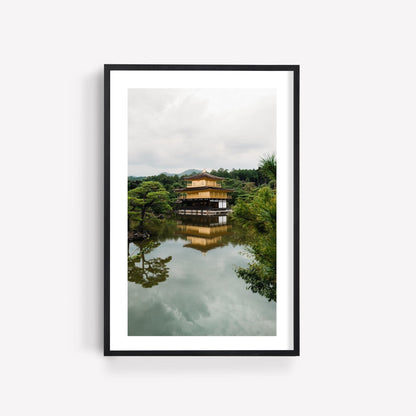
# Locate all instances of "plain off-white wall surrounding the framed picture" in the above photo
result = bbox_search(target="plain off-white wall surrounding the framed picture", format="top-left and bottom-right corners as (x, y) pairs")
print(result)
(0, 0), (416, 415)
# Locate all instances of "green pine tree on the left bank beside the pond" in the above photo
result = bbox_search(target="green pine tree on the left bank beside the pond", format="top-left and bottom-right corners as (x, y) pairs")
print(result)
(128, 181), (172, 230)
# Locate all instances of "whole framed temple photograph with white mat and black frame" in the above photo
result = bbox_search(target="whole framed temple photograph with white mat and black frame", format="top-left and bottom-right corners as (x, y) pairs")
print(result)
(104, 65), (299, 356)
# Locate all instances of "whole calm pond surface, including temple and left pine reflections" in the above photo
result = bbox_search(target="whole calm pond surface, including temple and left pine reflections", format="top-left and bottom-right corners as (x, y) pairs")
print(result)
(128, 217), (276, 336)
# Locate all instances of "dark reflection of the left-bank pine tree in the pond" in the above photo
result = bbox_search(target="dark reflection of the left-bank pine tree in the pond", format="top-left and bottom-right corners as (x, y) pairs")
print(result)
(128, 240), (172, 288)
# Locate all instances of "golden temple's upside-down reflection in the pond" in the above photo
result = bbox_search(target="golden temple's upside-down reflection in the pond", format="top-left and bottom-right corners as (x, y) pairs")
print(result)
(177, 215), (231, 254)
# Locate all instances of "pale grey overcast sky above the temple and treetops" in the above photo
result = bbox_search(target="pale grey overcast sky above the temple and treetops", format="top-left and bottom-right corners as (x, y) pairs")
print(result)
(128, 88), (276, 176)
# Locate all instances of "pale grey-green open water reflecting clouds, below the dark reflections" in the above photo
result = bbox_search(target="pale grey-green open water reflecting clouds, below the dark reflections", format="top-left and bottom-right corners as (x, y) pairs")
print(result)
(128, 240), (276, 336)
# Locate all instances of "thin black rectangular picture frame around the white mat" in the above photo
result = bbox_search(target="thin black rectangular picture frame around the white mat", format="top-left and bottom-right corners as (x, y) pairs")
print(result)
(104, 64), (300, 356)
